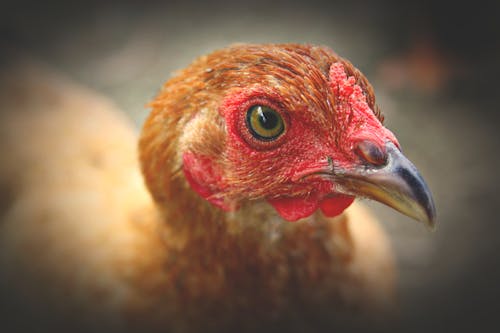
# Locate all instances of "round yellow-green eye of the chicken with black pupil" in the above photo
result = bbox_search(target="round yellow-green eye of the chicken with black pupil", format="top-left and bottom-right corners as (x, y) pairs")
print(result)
(246, 105), (285, 141)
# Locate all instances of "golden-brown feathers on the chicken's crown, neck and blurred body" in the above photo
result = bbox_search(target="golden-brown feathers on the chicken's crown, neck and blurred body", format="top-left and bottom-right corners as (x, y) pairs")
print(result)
(0, 45), (394, 332)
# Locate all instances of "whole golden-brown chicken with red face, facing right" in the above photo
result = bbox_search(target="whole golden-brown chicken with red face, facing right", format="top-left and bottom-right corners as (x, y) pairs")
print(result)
(0, 44), (435, 332)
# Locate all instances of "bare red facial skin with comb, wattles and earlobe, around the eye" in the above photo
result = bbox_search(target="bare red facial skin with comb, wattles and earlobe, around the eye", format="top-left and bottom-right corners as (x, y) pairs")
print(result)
(183, 62), (398, 221)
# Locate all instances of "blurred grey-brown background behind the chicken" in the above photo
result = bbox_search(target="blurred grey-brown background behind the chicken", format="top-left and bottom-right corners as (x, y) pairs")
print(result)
(0, 0), (500, 332)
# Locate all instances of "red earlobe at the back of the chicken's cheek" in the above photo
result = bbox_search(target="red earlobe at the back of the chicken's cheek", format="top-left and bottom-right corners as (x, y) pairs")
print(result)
(182, 152), (232, 211)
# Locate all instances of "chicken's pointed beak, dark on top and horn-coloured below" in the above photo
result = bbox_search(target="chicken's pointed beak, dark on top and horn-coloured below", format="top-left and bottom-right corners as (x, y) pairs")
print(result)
(334, 142), (436, 229)
